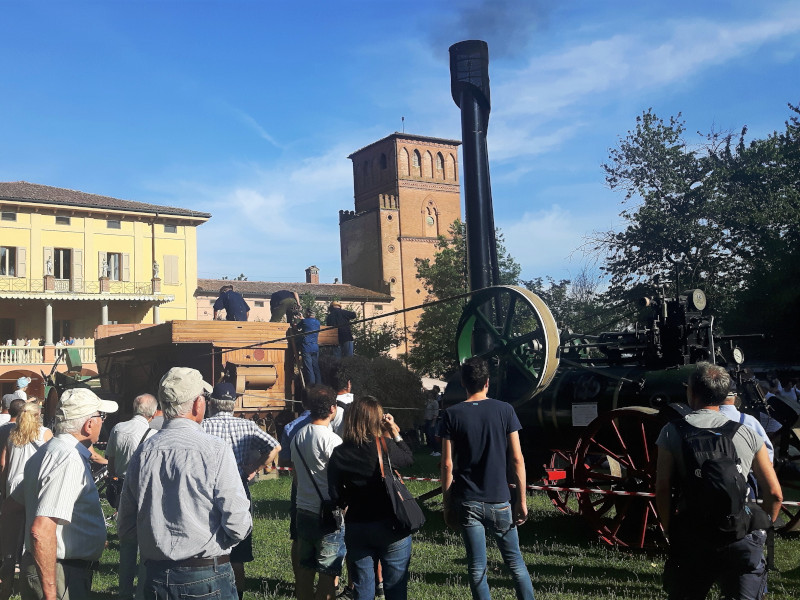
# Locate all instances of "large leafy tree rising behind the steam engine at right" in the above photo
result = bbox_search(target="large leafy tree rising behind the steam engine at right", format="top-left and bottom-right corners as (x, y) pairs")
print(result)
(588, 105), (800, 356)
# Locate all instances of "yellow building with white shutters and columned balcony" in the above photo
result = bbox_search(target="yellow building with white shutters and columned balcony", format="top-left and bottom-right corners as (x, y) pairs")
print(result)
(0, 181), (211, 393)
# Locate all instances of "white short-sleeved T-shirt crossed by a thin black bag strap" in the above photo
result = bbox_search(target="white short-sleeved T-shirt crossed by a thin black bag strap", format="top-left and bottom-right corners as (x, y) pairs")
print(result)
(291, 423), (342, 513)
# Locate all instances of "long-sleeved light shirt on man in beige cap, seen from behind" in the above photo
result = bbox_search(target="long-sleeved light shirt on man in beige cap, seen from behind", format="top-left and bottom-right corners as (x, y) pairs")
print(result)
(117, 418), (253, 560)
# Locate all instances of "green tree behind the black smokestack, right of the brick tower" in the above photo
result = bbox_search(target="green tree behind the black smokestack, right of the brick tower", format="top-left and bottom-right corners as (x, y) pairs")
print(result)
(407, 220), (521, 377)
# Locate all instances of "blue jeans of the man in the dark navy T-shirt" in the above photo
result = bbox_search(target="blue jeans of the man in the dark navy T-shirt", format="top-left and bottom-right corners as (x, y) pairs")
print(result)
(458, 500), (533, 600)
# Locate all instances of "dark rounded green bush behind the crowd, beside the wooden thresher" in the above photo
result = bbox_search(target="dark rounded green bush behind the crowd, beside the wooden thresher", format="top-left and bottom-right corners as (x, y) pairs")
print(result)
(320, 353), (425, 430)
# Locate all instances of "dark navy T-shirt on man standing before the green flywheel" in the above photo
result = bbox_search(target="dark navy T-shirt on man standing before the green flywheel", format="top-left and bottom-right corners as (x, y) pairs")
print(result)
(442, 398), (522, 502)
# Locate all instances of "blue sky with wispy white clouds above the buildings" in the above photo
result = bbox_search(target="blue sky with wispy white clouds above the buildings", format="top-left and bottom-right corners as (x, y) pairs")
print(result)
(0, 0), (800, 282)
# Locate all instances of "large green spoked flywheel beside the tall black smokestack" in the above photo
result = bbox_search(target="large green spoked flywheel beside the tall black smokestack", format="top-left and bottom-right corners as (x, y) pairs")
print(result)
(456, 286), (559, 405)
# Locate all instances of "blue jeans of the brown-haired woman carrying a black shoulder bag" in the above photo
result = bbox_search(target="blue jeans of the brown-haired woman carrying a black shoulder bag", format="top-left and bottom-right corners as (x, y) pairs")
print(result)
(344, 521), (411, 600)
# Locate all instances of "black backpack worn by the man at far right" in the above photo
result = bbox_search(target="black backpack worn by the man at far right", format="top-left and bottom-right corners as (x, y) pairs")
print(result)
(674, 419), (753, 543)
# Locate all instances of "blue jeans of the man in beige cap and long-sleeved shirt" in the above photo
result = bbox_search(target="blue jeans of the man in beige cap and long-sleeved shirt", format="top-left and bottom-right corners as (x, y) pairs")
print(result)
(144, 563), (239, 600)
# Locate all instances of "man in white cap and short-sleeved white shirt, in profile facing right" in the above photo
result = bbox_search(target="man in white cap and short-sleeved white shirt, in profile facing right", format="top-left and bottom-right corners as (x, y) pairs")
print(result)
(0, 388), (118, 600)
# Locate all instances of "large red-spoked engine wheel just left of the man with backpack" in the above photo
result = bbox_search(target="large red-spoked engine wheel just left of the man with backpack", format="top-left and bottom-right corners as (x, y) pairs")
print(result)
(575, 407), (666, 549)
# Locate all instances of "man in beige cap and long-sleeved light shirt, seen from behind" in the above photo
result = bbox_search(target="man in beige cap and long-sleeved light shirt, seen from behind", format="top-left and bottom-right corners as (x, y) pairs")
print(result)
(117, 367), (253, 600)
